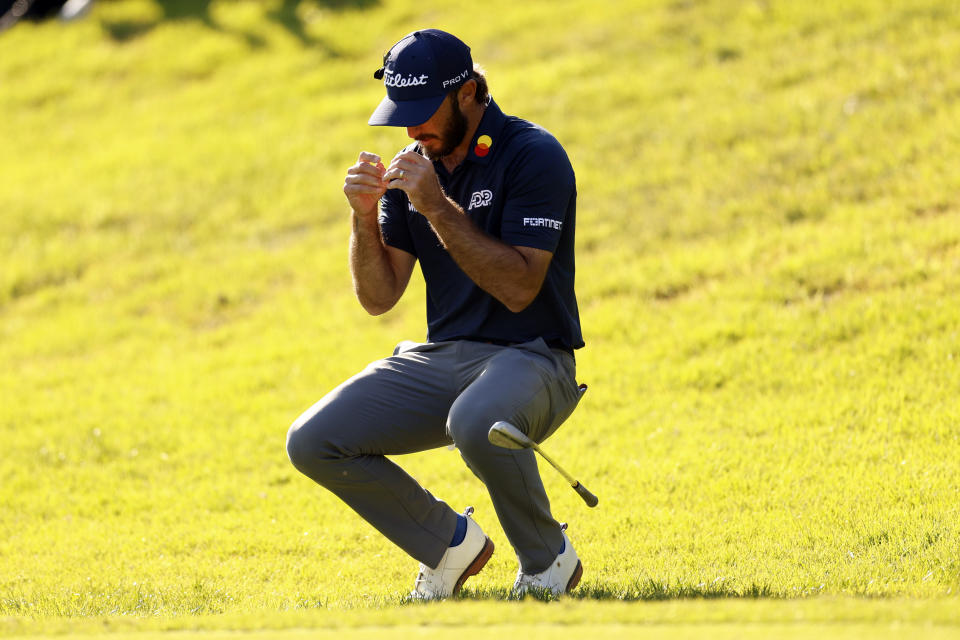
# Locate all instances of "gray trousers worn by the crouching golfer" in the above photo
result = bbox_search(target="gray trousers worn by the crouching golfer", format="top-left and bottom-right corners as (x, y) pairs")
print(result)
(287, 339), (579, 573)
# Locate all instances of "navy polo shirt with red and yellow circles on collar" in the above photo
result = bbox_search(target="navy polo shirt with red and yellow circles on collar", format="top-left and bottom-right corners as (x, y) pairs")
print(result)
(379, 100), (583, 349)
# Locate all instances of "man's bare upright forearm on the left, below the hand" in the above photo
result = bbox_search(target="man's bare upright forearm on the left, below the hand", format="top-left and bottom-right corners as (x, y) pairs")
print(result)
(350, 213), (402, 315)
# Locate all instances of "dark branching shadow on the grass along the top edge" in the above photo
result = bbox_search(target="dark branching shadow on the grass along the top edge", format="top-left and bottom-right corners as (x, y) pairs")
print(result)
(102, 0), (380, 48)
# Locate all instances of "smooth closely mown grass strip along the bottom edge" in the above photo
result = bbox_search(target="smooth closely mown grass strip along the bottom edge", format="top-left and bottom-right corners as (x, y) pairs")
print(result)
(5, 598), (958, 640)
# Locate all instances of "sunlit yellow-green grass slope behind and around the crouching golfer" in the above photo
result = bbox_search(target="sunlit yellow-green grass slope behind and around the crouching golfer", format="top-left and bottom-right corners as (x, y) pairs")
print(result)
(0, 0), (960, 637)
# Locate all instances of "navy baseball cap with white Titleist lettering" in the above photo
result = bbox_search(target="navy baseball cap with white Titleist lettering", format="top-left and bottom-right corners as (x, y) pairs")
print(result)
(368, 29), (473, 127)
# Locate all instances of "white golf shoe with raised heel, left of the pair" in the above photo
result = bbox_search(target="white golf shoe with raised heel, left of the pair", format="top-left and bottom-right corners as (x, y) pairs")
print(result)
(410, 507), (493, 600)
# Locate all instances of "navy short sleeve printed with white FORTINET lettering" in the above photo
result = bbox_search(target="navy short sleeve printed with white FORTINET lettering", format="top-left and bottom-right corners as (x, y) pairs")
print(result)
(500, 131), (576, 253)
